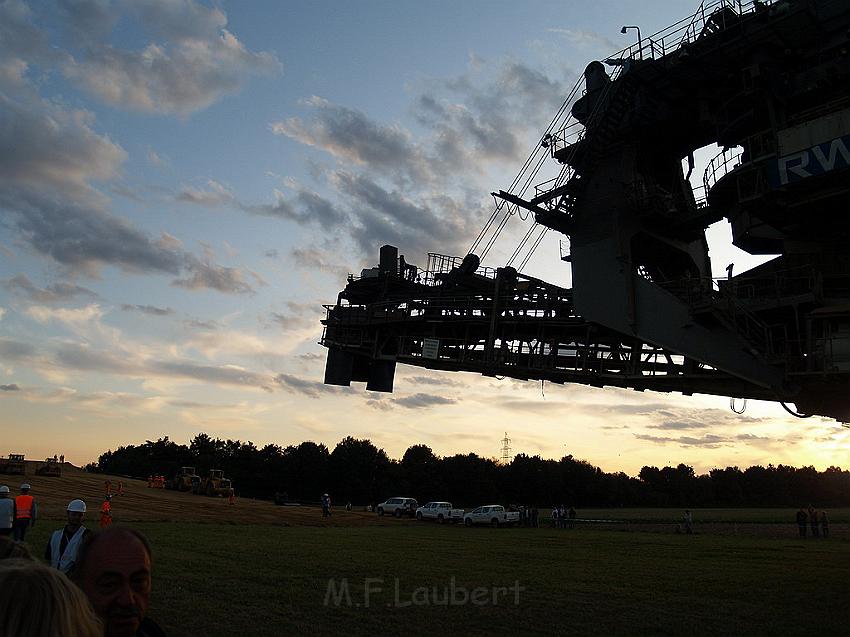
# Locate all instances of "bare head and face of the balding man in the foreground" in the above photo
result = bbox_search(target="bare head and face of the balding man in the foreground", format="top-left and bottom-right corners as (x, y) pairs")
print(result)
(80, 533), (151, 637)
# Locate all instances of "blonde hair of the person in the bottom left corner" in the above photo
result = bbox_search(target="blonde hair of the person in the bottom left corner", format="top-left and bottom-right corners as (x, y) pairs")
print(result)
(0, 558), (103, 637)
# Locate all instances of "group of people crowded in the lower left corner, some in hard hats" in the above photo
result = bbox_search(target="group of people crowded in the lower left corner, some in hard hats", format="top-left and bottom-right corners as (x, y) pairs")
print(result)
(0, 485), (165, 637)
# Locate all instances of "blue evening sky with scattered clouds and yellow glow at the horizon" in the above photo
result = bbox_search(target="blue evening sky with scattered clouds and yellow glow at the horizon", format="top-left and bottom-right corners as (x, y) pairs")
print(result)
(0, 0), (850, 475)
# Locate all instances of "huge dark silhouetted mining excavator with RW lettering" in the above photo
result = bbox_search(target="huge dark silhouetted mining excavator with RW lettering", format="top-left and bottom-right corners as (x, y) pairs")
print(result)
(321, 0), (850, 428)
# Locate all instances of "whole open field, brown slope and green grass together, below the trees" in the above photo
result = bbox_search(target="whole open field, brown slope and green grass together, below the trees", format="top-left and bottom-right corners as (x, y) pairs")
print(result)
(13, 466), (850, 637)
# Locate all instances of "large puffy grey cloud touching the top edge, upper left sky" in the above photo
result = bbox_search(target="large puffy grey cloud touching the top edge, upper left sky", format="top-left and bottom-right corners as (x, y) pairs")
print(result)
(63, 0), (282, 116)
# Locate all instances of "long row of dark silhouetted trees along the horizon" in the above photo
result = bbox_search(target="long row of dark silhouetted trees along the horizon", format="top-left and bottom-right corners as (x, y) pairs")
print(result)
(85, 433), (850, 507)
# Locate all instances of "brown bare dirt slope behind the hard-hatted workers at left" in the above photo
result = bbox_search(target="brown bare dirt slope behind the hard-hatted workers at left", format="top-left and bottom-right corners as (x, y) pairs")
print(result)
(0, 462), (400, 526)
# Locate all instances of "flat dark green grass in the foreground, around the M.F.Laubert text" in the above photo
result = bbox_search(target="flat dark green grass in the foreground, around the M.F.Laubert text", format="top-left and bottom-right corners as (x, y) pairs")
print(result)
(19, 512), (850, 637)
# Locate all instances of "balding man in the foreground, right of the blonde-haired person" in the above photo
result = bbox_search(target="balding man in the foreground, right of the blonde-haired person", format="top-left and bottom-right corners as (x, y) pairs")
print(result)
(74, 526), (166, 637)
